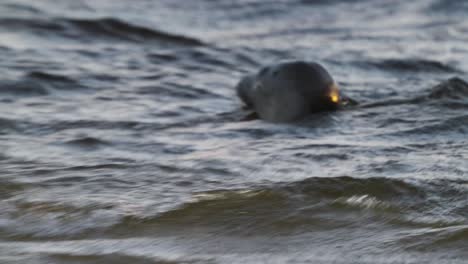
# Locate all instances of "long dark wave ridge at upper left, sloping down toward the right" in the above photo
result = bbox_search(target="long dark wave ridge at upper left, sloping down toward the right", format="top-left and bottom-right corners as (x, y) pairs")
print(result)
(0, 18), (203, 46)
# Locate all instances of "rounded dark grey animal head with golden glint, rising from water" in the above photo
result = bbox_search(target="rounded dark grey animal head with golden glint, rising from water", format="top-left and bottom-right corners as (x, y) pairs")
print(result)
(236, 61), (340, 122)
